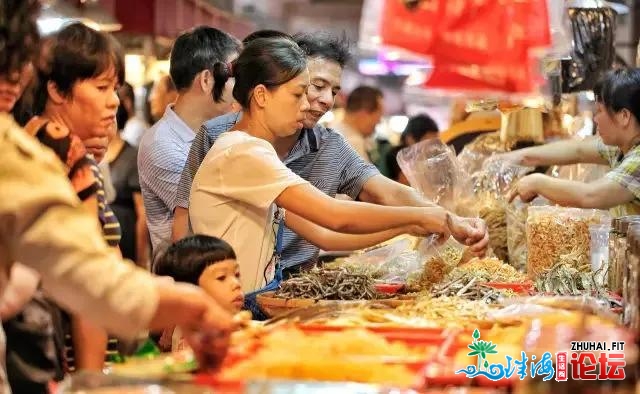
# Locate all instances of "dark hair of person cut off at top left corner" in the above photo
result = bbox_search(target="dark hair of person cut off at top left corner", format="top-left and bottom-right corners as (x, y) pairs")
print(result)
(0, 0), (40, 77)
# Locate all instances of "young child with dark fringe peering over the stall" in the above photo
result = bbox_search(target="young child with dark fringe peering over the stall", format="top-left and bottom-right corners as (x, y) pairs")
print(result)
(153, 235), (244, 351)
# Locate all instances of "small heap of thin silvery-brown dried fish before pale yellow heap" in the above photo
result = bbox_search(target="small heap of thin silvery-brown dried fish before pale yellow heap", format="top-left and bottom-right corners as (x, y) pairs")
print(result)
(431, 274), (516, 304)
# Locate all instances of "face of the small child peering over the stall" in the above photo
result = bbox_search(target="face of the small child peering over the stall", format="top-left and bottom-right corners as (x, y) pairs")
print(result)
(198, 260), (244, 313)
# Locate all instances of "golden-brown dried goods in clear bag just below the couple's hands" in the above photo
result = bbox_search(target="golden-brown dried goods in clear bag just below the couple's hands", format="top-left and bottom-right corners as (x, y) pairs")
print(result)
(406, 244), (464, 292)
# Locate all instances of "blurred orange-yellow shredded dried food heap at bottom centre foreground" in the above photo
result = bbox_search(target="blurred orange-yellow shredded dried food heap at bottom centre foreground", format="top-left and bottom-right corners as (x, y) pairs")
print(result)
(222, 328), (420, 387)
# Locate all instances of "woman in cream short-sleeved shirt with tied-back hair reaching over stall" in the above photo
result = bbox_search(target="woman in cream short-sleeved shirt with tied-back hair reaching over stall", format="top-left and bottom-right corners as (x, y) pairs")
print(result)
(189, 38), (486, 316)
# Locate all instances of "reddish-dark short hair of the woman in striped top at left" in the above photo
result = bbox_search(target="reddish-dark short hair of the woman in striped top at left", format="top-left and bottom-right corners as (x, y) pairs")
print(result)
(34, 23), (124, 114)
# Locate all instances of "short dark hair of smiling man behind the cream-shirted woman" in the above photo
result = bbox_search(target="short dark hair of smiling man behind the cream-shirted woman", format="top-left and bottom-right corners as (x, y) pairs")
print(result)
(293, 32), (351, 68)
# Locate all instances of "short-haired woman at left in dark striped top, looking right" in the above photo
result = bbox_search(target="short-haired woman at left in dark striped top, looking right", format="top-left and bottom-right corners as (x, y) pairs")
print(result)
(27, 23), (124, 370)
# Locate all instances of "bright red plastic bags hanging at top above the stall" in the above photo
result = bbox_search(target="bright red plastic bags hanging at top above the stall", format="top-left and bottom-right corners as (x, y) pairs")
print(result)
(381, 0), (551, 92)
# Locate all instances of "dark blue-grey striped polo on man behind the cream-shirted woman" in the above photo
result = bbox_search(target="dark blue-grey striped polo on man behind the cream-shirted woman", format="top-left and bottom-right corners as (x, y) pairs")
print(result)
(174, 113), (380, 268)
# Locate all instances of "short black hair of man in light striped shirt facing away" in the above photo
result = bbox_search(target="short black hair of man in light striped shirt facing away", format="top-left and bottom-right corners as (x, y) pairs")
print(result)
(169, 26), (240, 102)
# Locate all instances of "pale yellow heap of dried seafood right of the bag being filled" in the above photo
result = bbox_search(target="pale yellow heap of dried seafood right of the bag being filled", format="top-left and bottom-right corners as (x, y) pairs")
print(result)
(447, 258), (527, 283)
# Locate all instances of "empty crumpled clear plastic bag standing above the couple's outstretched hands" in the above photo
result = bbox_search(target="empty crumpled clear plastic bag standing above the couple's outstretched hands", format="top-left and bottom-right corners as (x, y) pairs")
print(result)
(397, 139), (465, 210)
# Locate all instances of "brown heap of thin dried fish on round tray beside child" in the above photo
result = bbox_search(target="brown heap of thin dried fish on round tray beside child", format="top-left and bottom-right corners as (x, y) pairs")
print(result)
(275, 268), (379, 300)
